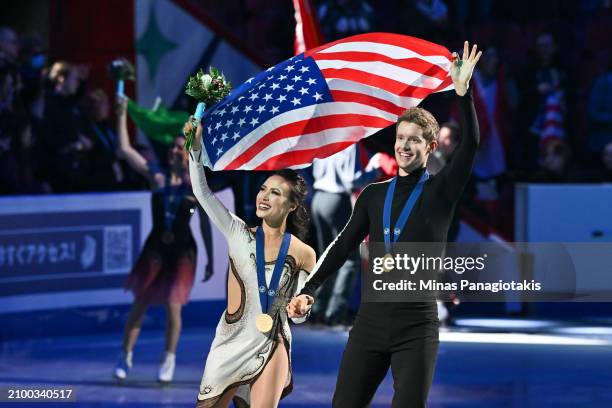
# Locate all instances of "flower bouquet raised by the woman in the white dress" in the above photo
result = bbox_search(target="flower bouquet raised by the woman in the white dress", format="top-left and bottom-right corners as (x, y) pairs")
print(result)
(185, 67), (232, 150)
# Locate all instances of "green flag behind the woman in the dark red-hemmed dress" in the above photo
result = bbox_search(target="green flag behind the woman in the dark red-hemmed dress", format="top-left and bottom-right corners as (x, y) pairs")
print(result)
(128, 100), (189, 145)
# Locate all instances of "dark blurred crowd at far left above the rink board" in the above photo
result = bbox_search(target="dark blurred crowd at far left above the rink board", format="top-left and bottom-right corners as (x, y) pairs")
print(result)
(0, 27), (152, 195)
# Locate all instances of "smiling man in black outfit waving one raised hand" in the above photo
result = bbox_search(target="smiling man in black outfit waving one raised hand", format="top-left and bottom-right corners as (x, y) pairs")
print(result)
(287, 41), (481, 408)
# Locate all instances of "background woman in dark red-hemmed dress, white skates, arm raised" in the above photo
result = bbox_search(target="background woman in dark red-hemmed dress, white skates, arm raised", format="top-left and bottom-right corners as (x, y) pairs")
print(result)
(114, 97), (197, 382)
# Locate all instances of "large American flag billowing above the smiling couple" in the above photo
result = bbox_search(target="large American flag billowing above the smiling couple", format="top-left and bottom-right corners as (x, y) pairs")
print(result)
(203, 33), (452, 170)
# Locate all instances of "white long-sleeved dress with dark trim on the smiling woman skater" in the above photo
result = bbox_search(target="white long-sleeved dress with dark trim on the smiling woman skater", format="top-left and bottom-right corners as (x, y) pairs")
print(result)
(189, 151), (308, 408)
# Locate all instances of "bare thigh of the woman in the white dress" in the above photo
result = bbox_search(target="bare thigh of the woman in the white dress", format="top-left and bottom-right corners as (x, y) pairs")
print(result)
(251, 340), (289, 408)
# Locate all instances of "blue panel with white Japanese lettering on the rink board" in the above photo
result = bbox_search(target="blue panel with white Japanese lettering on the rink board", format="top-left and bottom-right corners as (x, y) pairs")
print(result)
(0, 207), (140, 296)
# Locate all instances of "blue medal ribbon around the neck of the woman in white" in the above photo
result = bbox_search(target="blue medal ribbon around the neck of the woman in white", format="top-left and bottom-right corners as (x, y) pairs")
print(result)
(255, 227), (291, 313)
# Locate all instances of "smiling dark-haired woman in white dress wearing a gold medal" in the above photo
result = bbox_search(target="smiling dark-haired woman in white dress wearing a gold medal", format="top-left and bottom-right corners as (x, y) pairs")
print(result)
(185, 118), (316, 408)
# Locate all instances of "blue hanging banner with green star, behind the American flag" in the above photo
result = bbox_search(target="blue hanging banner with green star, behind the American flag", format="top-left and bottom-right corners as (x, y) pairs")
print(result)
(133, 0), (262, 110)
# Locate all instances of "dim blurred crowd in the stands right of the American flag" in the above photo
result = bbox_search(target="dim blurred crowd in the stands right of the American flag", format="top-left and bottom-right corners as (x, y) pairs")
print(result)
(203, 0), (612, 239)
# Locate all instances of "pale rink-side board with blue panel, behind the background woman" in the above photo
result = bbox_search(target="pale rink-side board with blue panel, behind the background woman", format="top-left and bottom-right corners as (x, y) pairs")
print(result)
(0, 191), (233, 316)
